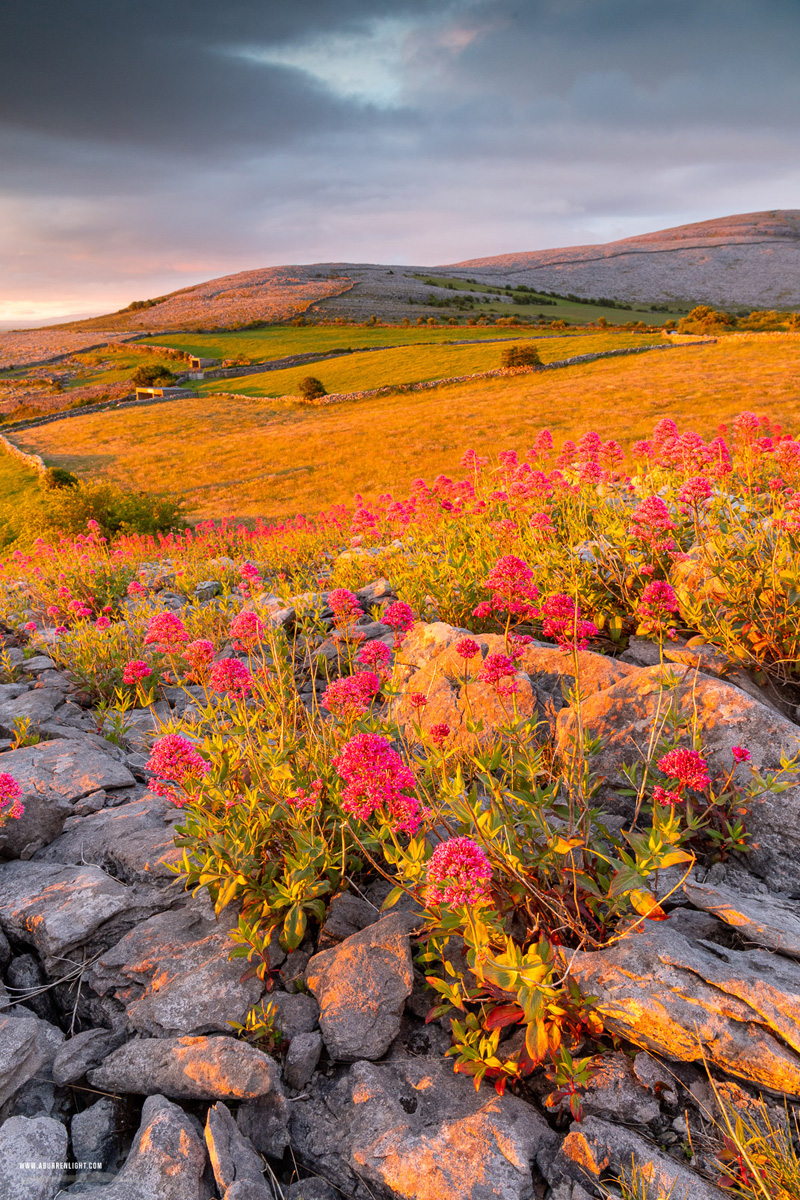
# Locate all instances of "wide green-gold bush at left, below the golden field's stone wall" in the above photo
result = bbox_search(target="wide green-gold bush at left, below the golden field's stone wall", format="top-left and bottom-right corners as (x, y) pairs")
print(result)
(43, 472), (186, 538)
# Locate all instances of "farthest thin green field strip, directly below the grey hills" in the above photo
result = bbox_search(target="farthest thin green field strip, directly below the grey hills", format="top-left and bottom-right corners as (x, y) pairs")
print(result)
(134, 314), (642, 362)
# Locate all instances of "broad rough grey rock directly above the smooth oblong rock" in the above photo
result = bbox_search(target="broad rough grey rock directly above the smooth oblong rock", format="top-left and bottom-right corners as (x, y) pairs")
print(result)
(85, 904), (263, 1037)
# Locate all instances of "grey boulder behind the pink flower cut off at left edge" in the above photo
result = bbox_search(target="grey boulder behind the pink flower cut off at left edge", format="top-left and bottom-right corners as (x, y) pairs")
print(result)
(0, 738), (134, 858)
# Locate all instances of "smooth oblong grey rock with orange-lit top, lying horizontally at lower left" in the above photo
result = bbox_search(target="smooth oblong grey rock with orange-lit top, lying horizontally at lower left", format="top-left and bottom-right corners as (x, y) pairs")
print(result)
(88, 1037), (281, 1100)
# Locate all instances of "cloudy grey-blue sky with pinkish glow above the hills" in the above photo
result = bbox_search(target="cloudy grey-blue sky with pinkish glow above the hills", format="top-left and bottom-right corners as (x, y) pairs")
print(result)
(0, 0), (800, 326)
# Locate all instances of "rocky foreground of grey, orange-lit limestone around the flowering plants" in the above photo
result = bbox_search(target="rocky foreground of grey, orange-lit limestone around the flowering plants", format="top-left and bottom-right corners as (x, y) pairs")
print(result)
(0, 581), (800, 1200)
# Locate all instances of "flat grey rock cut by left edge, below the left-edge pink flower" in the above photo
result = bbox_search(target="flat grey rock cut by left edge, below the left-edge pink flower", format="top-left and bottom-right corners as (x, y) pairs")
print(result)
(0, 862), (164, 970)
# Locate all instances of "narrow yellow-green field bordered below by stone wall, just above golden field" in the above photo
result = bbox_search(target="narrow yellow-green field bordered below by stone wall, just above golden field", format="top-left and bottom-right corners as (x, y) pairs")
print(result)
(197, 332), (662, 396)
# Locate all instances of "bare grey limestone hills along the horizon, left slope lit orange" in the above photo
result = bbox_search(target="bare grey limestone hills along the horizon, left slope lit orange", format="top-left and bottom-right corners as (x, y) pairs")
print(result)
(50, 209), (800, 332)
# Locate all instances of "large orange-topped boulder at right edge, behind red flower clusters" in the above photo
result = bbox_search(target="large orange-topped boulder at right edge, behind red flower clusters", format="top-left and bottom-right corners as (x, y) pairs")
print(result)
(557, 666), (800, 890)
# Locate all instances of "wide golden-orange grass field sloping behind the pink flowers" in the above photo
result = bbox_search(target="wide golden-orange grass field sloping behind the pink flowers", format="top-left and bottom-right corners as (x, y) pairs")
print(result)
(17, 334), (800, 518)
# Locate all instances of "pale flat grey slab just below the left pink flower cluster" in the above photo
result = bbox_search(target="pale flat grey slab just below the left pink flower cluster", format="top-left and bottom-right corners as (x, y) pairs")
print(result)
(36, 792), (181, 883)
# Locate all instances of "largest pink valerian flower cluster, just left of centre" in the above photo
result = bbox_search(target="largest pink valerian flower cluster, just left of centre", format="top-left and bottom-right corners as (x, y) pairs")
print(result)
(333, 733), (421, 834)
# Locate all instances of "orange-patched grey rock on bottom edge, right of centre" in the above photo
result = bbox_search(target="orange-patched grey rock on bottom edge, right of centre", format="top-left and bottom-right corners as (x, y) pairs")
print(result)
(547, 1117), (729, 1200)
